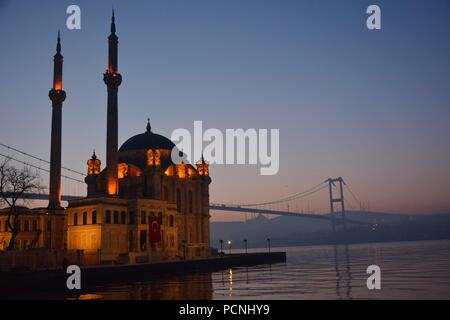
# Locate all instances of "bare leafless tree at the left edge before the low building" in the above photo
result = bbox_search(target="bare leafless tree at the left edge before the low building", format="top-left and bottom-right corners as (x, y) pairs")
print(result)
(0, 159), (44, 250)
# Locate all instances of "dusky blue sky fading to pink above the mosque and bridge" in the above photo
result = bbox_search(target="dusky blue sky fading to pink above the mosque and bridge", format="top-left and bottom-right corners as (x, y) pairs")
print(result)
(0, 0), (450, 220)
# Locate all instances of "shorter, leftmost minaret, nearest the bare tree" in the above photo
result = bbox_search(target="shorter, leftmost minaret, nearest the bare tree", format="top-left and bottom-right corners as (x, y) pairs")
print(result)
(48, 31), (66, 210)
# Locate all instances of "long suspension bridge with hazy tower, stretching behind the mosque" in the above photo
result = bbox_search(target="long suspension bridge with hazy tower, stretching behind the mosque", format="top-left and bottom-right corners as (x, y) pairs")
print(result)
(0, 142), (367, 229)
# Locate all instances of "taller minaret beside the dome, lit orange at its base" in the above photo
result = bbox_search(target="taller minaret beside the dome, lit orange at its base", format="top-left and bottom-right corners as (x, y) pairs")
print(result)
(103, 10), (122, 196)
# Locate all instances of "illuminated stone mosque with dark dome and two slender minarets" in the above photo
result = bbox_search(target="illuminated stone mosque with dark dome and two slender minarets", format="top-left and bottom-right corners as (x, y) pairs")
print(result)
(0, 12), (211, 264)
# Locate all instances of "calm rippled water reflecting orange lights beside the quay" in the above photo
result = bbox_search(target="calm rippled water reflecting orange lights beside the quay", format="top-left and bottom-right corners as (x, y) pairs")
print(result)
(64, 240), (450, 299)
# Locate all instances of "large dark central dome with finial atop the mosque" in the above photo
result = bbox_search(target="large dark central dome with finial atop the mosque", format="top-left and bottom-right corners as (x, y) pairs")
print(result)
(119, 124), (175, 151)
